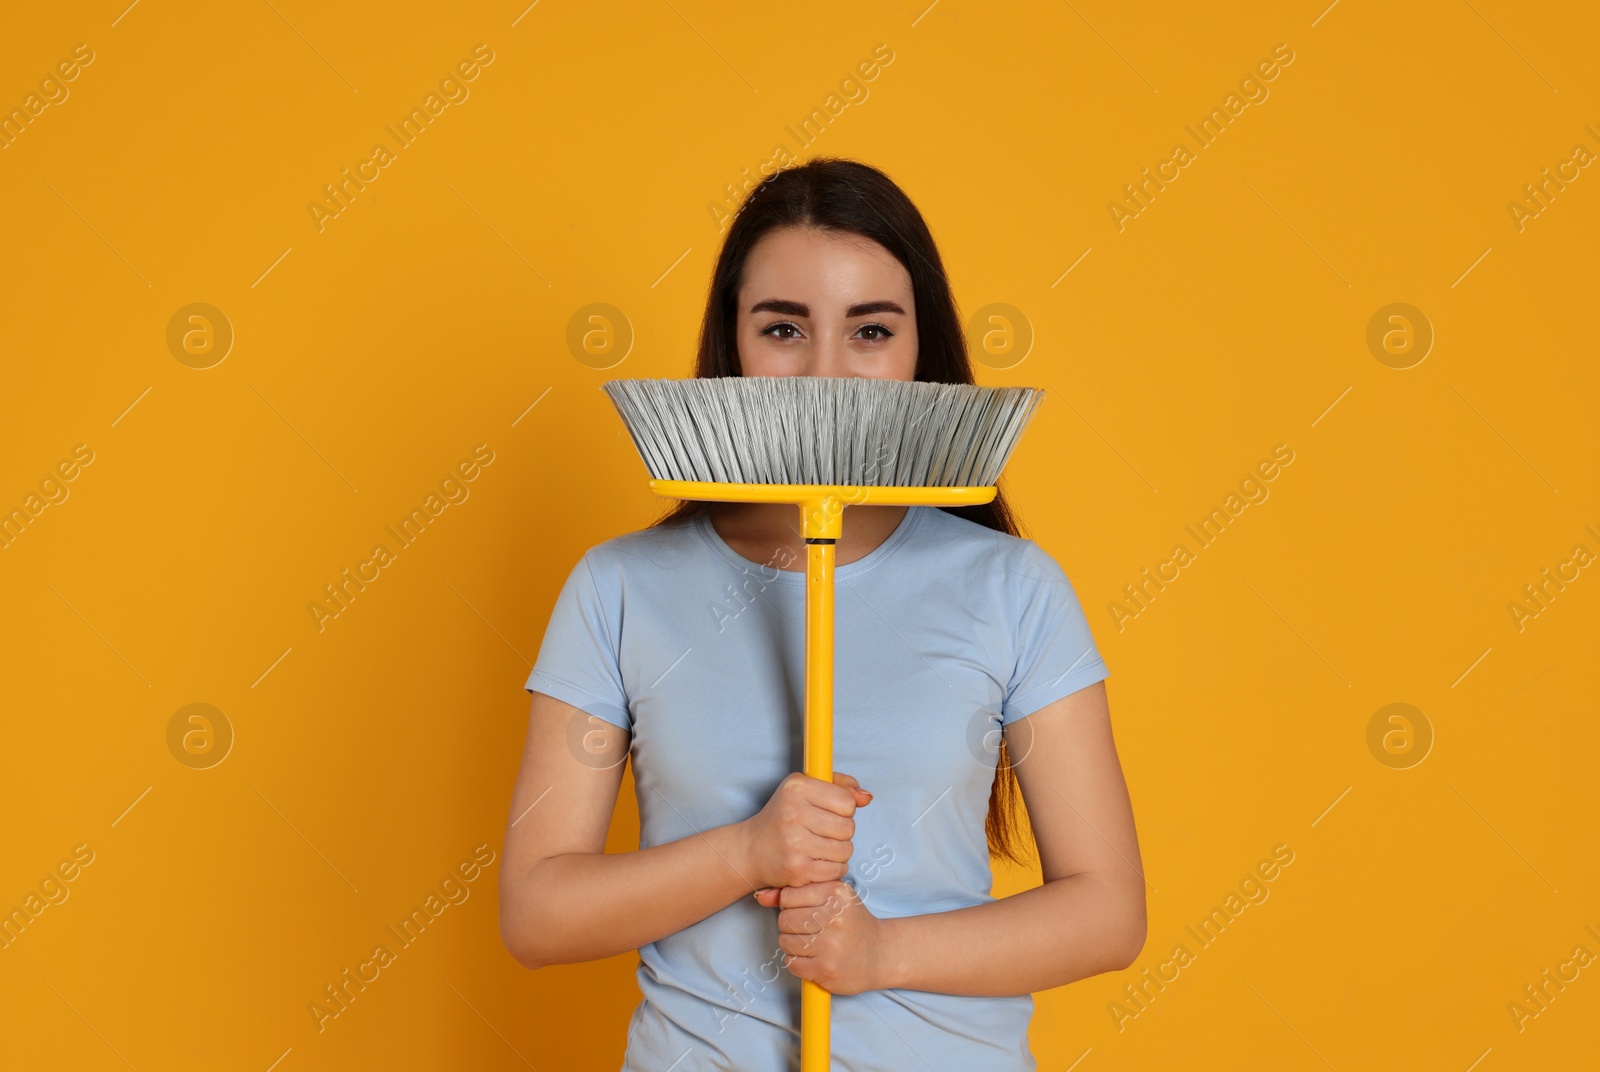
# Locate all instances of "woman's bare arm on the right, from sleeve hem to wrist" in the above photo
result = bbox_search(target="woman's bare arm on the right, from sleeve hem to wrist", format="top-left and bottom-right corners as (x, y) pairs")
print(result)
(880, 682), (1146, 995)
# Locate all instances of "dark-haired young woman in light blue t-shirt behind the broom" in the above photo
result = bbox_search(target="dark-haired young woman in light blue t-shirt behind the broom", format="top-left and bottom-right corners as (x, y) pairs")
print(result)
(501, 158), (1146, 1072)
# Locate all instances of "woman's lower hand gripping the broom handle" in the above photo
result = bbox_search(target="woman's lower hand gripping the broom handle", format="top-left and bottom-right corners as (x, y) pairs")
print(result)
(755, 878), (886, 994)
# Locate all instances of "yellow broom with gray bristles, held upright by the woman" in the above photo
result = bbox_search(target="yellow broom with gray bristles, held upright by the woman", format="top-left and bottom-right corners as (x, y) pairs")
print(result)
(603, 376), (1045, 1072)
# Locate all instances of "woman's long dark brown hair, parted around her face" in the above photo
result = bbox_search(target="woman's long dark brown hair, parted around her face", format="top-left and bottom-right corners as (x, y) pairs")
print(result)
(651, 157), (1024, 864)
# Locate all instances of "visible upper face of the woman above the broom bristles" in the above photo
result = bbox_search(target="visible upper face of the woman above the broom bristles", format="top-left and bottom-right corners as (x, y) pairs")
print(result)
(736, 227), (917, 379)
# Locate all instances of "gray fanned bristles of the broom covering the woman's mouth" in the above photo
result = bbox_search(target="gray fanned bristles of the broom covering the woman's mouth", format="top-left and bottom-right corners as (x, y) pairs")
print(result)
(603, 376), (1045, 488)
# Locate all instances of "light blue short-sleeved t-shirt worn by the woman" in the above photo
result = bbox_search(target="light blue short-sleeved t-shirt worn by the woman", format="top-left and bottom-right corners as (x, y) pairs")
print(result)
(525, 506), (1109, 1072)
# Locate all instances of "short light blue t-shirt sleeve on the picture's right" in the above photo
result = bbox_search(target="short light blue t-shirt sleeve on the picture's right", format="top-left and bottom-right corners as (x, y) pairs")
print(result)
(1000, 541), (1110, 725)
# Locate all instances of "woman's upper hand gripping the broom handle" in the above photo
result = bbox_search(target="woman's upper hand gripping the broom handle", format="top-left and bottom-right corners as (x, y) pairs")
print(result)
(741, 771), (872, 890)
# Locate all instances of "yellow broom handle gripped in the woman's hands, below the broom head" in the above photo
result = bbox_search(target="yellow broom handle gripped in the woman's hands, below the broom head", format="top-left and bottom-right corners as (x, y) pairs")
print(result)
(800, 496), (845, 1072)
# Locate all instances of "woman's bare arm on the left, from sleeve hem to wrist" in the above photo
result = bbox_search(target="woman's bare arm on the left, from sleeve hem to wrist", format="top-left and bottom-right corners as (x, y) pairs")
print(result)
(499, 693), (760, 968)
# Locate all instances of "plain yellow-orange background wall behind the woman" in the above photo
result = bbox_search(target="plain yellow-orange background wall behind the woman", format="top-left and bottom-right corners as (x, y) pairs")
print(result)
(0, 0), (1600, 1072)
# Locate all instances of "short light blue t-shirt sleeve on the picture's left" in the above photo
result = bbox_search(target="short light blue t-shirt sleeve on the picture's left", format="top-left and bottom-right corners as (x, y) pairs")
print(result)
(523, 552), (634, 730)
